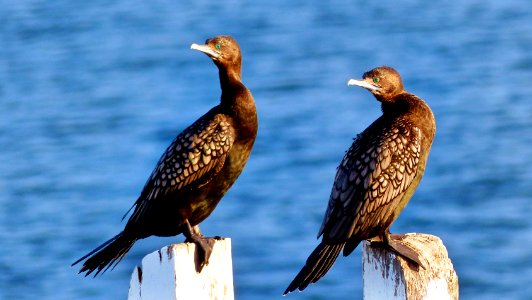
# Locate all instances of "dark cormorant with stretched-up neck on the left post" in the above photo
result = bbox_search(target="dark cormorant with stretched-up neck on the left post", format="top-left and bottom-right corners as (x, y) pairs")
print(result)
(72, 36), (258, 276)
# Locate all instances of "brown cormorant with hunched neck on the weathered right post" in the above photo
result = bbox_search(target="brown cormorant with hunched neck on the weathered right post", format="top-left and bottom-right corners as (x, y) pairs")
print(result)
(284, 66), (436, 295)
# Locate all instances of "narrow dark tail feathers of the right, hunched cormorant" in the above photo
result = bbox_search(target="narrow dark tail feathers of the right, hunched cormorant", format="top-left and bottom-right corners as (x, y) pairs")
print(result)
(283, 242), (345, 295)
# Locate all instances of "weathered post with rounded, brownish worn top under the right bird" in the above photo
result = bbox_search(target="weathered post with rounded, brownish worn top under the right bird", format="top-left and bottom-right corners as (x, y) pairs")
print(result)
(362, 233), (458, 300)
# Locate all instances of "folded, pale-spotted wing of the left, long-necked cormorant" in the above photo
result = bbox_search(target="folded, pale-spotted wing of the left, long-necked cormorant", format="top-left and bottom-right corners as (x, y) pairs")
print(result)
(126, 111), (235, 220)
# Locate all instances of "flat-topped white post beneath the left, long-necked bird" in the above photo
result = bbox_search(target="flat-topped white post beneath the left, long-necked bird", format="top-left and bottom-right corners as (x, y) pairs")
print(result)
(128, 238), (234, 300)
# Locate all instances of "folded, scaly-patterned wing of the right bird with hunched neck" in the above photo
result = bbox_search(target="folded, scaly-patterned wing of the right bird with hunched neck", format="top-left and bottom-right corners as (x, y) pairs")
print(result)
(318, 118), (421, 243)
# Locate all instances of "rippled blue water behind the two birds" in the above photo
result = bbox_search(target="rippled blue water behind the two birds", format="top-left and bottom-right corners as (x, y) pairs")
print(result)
(0, 0), (532, 300)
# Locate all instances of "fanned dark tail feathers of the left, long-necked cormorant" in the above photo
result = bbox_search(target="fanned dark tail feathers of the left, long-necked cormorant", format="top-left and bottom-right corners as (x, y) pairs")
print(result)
(72, 231), (137, 277)
